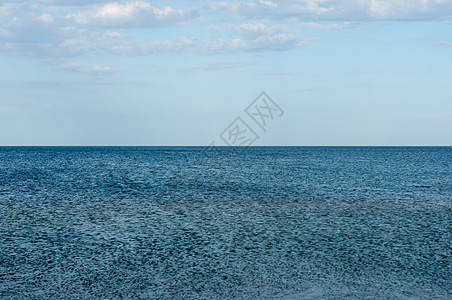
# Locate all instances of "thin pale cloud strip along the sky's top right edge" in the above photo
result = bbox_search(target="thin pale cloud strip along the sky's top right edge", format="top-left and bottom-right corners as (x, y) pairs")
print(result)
(208, 0), (452, 21)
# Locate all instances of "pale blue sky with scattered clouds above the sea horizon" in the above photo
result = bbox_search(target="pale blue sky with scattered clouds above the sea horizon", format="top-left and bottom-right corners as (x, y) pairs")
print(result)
(0, 0), (452, 146)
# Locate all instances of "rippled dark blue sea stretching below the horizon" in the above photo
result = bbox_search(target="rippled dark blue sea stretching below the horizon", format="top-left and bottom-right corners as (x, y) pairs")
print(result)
(0, 147), (452, 299)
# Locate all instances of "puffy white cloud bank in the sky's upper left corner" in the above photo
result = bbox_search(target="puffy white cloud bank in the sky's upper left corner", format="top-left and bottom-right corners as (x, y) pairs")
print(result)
(0, 1), (200, 59)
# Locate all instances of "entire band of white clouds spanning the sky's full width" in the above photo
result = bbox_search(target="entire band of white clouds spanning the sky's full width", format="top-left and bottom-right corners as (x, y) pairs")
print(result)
(0, 0), (452, 59)
